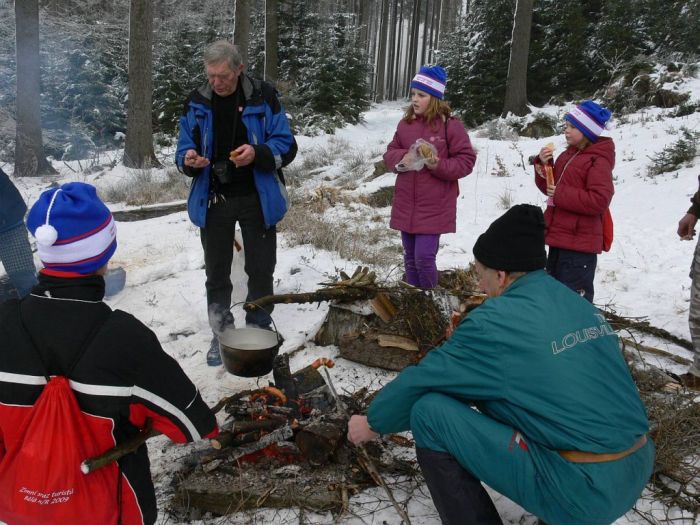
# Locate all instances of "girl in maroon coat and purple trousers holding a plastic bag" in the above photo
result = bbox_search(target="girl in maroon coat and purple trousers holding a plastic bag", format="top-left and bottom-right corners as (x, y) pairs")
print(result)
(384, 66), (476, 288)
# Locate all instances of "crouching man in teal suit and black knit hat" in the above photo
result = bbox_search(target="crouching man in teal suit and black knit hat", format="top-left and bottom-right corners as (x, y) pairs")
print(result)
(348, 204), (655, 525)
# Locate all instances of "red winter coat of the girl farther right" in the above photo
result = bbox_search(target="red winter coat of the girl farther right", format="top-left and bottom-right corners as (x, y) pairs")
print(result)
(535, 137), (615, 253)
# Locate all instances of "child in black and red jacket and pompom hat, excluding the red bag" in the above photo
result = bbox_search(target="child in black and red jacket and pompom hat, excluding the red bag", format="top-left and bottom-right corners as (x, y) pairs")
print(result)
(0, 182), (218, 525)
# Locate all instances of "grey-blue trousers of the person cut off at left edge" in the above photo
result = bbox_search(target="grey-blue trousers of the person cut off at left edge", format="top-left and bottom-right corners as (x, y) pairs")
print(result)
(0, 223), (36, 297)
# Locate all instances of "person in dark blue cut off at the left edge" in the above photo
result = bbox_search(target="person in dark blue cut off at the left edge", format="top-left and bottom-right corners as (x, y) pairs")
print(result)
(0, 169), (36, 298)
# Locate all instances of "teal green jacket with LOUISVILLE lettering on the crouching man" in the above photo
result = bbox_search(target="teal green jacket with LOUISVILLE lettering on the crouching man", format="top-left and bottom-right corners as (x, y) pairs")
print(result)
(368, 270), (649, 453)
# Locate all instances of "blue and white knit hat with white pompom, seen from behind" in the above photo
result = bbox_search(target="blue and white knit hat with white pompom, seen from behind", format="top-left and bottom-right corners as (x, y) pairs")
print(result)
(27, 182), (117, 275)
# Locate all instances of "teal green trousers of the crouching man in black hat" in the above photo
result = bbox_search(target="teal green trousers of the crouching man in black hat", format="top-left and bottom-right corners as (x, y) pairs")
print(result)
(411, 393), (655, 525)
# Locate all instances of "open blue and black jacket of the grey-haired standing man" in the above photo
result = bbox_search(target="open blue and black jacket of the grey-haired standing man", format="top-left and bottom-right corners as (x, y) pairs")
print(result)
(175, 75), (297, 228)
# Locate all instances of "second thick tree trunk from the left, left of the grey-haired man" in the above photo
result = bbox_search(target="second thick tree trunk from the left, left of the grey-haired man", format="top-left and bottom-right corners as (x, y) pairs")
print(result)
(122, 0), (160, 168)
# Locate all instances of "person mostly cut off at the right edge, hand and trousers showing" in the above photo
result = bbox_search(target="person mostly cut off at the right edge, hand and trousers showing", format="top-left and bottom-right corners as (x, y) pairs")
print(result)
(678, 176), (700, 390)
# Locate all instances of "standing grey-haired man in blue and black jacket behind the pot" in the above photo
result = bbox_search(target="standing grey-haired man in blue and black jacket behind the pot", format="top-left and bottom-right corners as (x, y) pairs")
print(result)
(175, 40), (297, 366)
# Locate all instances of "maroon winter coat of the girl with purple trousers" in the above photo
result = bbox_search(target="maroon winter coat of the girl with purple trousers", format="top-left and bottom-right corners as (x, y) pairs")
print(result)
(384, 117), (476, 234)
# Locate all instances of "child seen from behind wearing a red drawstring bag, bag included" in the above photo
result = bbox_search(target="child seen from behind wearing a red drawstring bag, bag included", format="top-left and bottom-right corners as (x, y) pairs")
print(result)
(0, 182), (218, 525)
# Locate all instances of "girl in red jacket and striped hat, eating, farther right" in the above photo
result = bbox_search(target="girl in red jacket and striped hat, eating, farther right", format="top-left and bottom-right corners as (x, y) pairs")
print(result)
(535, 100), (615, 302)
